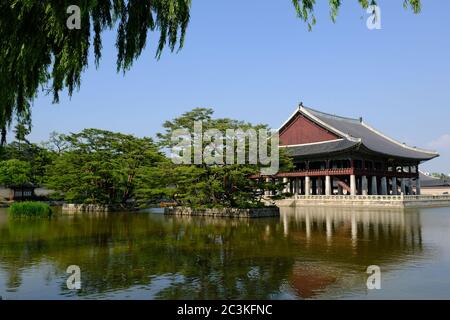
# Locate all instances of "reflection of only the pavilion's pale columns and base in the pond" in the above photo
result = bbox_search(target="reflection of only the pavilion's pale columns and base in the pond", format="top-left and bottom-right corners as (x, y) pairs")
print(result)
(282, 207), (423, 254)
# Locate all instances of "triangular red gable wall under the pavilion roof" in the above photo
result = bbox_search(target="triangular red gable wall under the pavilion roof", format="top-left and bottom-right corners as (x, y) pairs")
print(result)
(280, 114), (339, 146)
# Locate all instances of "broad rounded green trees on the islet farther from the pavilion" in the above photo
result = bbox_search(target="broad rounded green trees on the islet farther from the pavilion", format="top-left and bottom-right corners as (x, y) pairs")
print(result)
(46, 129), (165, 205)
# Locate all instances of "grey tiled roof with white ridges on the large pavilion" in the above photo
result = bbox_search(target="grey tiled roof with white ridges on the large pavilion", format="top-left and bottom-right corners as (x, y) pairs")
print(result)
(278, 105), (439, 161)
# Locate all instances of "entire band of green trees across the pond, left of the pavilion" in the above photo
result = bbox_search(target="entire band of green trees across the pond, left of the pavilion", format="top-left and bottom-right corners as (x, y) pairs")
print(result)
(0, 108), (292, 208)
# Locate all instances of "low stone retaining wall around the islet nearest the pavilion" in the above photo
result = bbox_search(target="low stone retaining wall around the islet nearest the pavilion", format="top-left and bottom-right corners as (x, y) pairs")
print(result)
(164, 207), (280, 218)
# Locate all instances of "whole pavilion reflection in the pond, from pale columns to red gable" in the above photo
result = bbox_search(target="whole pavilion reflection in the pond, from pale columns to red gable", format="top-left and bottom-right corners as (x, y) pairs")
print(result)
(281, 207), (424, 299)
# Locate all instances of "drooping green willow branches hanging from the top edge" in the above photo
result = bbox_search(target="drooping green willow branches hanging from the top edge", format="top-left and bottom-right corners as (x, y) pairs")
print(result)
(0, 0), (421, 141)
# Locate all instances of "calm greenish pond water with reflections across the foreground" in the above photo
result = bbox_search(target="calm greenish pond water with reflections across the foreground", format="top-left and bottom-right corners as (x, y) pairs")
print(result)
(0, 208), (450, 299)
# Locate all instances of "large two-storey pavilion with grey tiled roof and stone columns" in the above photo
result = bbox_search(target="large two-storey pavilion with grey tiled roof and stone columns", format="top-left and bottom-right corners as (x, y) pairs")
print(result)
(266, 104), (439, 196)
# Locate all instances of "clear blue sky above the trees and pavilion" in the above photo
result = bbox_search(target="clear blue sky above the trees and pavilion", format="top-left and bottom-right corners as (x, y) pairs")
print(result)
(26, 0), (450, 173)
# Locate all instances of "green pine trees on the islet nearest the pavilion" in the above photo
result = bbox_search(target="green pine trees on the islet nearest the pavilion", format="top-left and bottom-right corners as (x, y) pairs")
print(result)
(158, 108), (292, 208)
